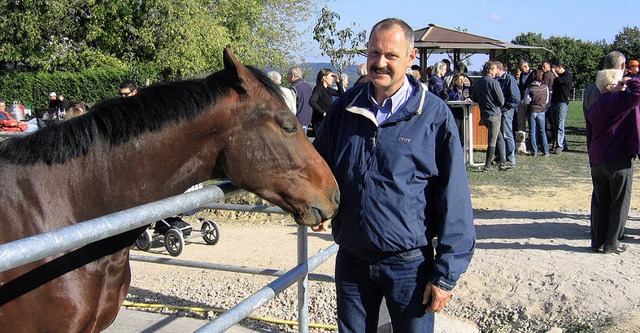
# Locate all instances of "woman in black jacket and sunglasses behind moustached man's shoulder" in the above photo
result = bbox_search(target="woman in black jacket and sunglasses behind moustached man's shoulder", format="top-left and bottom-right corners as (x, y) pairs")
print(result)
(309, 68), (344, 131)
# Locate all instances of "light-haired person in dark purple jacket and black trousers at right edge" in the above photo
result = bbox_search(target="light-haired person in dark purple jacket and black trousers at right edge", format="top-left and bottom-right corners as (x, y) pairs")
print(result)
(586, 69), (640, 254)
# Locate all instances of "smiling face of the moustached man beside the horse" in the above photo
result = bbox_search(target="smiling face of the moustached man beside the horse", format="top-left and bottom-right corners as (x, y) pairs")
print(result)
(367, 25), (416, 97)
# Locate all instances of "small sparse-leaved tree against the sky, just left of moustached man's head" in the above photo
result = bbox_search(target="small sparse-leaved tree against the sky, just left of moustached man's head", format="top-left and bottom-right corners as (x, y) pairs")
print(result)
(313, 7), (367, 74)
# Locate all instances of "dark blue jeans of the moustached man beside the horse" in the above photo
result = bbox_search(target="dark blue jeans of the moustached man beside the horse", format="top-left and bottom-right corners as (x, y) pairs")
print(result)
(336, 249), (435, 333)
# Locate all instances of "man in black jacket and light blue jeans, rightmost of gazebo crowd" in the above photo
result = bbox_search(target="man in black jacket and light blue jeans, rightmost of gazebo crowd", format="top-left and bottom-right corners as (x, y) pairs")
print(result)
(549, 58), (573, 154)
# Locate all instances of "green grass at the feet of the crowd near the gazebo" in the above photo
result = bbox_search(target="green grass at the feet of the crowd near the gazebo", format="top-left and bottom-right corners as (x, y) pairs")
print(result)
(467, 101), (591, 192)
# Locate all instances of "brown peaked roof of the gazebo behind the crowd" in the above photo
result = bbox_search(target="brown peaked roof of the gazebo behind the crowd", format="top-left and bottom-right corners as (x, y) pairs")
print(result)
(413, 23), (549, 68)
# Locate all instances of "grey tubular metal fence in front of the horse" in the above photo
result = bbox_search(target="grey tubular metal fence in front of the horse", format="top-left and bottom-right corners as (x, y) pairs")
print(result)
(0, 182), (338, 333)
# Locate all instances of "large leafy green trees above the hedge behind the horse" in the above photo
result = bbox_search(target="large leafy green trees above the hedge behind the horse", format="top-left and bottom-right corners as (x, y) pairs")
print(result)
(0, 0), (325, 76)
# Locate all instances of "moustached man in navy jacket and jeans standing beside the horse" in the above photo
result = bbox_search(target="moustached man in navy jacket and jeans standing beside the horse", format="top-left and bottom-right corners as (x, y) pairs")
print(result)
(314, 18), (475, 333)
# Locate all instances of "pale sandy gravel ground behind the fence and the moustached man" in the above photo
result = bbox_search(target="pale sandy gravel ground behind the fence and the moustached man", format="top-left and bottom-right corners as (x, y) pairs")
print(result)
(122, 204), (640, 332)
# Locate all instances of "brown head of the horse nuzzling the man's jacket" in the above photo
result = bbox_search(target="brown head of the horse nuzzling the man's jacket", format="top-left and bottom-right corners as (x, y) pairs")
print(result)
(212, 47), (340, 226)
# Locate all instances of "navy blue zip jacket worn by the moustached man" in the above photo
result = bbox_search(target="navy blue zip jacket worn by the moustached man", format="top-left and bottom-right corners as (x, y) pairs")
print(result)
(314, 77), (476, 290)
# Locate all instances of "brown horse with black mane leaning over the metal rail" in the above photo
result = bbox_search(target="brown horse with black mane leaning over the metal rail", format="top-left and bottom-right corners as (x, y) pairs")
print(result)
(0, 49), (339, 332)
